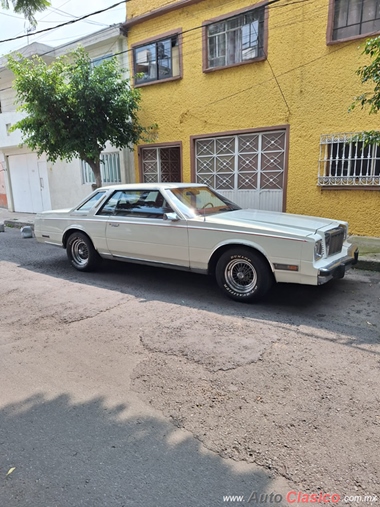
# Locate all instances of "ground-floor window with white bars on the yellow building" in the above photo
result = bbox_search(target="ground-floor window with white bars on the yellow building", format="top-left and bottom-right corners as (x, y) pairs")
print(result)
(318, 133), (380, 187)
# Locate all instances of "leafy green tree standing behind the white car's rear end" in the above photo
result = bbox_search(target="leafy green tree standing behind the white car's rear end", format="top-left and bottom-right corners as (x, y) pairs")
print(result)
(8, 48), (156, 187)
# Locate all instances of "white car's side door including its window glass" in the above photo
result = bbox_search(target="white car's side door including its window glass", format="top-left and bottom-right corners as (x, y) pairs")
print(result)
(98, 189), (189, 268)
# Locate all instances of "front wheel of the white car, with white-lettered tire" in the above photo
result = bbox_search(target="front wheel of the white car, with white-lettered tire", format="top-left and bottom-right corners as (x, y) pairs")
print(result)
(215, 247), (274, 303)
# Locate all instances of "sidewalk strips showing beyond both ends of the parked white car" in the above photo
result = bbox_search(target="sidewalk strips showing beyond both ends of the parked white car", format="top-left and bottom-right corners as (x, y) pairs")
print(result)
(0, 208), (380, 271)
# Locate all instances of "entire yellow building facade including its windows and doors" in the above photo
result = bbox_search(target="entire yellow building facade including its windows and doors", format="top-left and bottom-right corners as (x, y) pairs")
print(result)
(123, 0), (380, 236)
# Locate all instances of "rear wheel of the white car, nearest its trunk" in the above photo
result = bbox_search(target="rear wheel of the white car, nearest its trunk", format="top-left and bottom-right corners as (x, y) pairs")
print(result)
(66, 232), (101, 271)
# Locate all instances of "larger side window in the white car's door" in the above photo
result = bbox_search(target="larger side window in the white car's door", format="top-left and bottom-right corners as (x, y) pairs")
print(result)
(97, 190), (173, 218)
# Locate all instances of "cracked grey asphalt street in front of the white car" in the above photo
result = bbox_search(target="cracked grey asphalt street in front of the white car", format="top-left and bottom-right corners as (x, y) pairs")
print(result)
(0, 228), (380, 507)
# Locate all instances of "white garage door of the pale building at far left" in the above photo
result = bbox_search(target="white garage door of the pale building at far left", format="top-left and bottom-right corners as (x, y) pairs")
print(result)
(8, 153), (51, 213)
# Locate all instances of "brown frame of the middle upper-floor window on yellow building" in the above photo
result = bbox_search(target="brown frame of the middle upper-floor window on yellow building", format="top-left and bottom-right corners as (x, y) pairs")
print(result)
(202, 0), (269, 73)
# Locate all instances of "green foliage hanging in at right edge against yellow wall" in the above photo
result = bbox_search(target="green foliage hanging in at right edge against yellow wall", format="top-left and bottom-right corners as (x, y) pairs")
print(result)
(350, 37), (380, 145)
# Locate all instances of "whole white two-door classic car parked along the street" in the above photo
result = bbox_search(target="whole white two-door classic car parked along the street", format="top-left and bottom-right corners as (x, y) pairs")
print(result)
(35, 183), (358, 302)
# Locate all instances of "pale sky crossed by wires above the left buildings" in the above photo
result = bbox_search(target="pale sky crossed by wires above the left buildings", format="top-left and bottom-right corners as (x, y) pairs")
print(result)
(0, 0), (126, 57)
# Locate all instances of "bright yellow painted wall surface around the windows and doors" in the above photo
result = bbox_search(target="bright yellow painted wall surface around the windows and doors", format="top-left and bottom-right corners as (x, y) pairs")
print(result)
(128, 0), (380, 236)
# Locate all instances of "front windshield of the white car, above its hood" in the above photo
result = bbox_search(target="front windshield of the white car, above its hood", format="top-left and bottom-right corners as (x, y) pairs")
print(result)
(169, 187), (241, 216)
